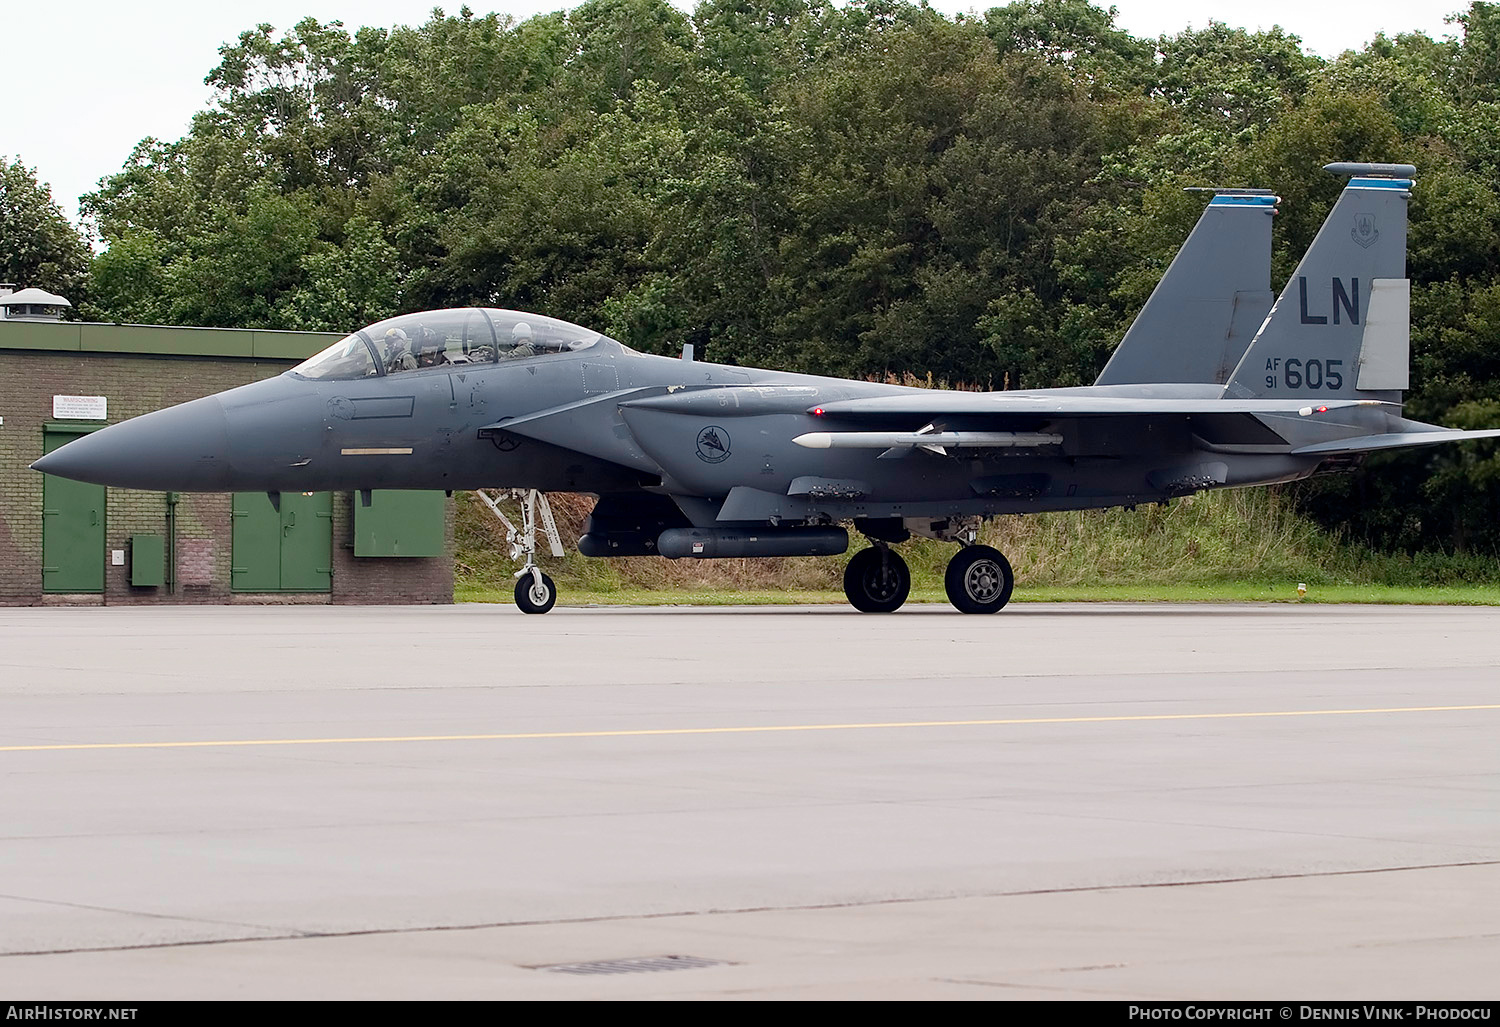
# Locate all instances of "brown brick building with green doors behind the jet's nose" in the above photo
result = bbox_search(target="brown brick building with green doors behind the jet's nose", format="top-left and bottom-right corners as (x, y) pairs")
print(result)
(0, 304), (453, 606)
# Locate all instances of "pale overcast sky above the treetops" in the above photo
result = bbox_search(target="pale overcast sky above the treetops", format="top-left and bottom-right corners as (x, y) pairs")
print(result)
(0, 0), (1469, 226)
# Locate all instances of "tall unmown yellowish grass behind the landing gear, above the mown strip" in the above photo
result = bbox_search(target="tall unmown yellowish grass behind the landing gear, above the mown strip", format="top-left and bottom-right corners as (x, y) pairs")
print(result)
(456, 489), (1500, 592)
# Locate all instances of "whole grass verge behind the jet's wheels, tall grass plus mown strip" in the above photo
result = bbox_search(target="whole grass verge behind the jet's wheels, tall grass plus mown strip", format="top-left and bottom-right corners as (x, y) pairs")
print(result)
(455, 489), (1500, 606)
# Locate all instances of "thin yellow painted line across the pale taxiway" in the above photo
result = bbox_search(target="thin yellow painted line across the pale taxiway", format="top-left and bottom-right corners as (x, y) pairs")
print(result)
(0, 703), (1500, 753)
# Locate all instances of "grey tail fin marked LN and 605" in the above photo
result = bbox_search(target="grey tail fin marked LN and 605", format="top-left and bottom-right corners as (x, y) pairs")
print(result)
(1226, 163), (1416, 403)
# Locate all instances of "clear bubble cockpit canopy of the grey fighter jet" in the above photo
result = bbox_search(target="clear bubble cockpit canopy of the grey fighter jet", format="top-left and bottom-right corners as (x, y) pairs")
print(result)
(293, 307), (605, 379)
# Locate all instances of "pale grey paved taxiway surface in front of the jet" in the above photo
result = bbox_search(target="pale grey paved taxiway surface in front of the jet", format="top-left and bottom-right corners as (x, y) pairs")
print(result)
(0, 604), (1500, 1000)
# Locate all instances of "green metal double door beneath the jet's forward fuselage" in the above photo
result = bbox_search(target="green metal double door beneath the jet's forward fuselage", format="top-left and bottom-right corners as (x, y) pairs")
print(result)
(231, 492), (333, 592)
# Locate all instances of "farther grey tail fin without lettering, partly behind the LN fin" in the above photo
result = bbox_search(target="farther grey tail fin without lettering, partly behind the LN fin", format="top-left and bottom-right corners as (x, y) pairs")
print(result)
(1094, 189), (1277, 385)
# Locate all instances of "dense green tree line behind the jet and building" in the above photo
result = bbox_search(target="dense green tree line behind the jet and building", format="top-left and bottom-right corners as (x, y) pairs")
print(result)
(0, 0), (1500, 553)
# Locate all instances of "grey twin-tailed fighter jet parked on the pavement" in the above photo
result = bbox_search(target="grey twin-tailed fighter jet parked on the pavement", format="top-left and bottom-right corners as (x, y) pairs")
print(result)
(32, 163), (1500, 613)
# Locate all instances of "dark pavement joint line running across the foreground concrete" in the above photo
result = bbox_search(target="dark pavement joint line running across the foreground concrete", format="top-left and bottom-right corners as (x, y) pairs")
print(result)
(0, 859), (1500, 960)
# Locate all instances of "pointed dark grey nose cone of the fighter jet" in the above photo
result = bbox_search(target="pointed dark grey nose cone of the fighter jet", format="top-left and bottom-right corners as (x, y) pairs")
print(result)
(32, 396), (230, 492)
